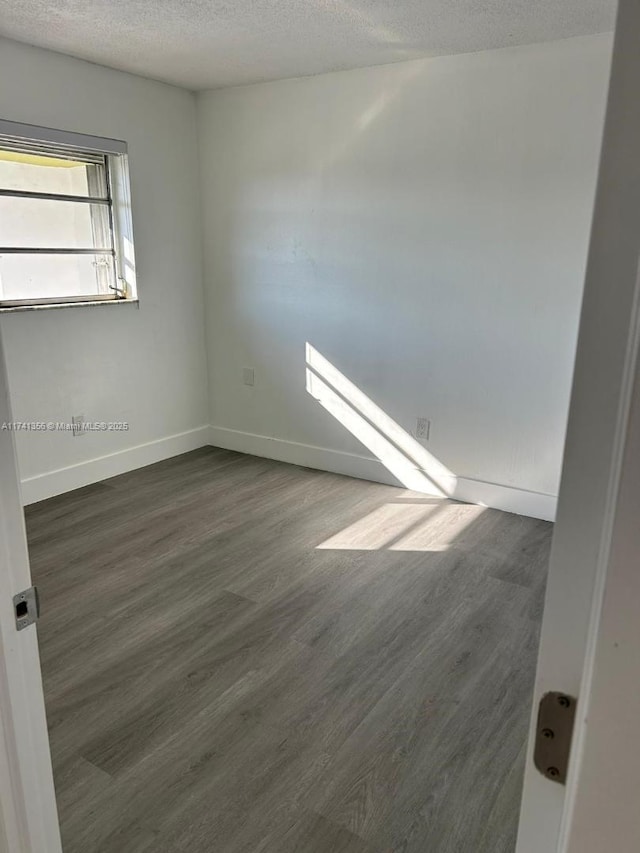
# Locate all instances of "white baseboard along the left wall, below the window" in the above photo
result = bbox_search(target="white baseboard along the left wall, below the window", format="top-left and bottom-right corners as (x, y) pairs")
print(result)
(21, 426), (209, 506)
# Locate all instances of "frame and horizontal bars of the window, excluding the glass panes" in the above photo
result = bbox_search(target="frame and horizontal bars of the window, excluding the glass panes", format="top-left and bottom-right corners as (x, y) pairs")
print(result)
(0, 120), (138, 313)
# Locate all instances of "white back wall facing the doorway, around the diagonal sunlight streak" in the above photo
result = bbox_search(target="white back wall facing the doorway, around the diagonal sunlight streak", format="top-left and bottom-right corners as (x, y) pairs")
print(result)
(198, 36), (611, 514)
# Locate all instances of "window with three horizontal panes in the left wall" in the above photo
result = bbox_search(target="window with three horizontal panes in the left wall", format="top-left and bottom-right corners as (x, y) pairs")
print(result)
(0, 121), (136, 311)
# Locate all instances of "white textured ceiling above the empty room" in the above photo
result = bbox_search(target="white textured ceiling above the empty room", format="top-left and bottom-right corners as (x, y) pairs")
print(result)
(0, 0), (616, 89)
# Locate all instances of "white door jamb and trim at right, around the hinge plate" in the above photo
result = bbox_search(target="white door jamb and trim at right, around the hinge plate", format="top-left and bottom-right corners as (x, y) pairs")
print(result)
(517, 0), (640, 853)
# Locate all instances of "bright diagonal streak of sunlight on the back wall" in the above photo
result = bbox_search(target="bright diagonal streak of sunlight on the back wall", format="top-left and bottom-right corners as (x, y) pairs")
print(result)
(306, 342), (458, 497)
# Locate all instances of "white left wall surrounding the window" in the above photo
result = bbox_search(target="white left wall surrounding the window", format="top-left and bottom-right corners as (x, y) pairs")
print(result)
(0, 39), (208, 500)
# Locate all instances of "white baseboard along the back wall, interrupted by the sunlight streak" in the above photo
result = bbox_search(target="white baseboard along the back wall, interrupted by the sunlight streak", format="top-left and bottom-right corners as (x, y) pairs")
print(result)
(209, 426), (557, 521)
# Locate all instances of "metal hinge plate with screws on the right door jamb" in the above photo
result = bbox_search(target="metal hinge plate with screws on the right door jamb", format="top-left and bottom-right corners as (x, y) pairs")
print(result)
(533, 693), (578, 785)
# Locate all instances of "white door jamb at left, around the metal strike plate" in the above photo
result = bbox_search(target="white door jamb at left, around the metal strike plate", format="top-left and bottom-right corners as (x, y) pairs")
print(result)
(0, 330), (62, 853)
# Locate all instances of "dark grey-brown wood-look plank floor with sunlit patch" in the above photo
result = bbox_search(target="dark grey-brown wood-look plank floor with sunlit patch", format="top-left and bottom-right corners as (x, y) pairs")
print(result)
(26, 448), (551, 853)
